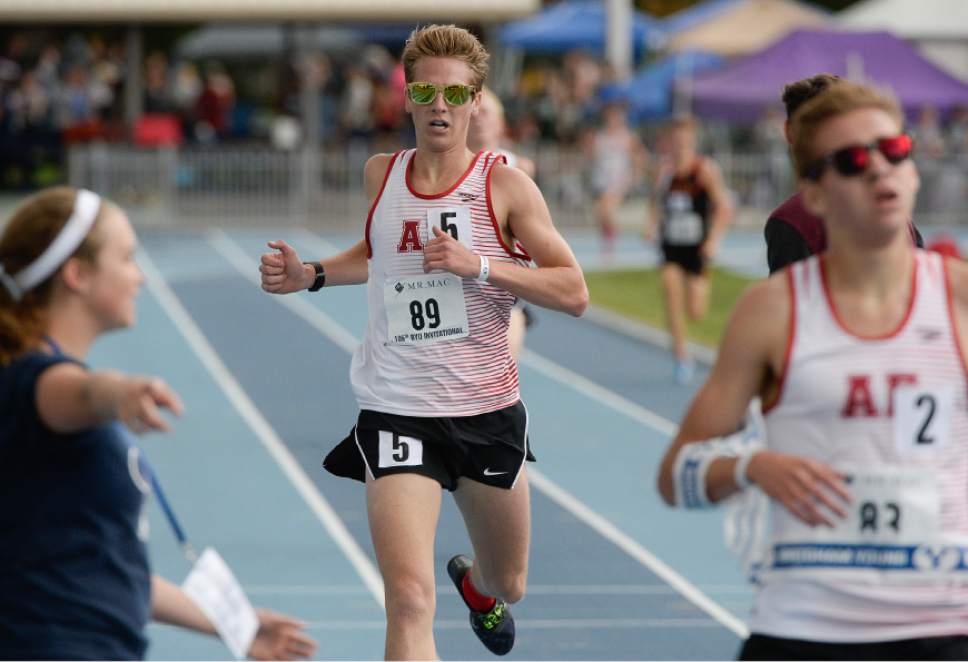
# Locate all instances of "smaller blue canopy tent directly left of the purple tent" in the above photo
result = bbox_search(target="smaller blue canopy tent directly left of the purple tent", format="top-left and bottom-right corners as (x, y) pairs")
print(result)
(600, 51), (726, 122)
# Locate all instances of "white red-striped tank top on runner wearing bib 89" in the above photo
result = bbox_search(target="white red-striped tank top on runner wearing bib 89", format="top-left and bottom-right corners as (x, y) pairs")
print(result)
(350, 150), (530, 416)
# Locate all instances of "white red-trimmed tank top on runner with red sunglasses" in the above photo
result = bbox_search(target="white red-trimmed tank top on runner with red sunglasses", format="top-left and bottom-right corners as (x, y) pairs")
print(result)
(750, 251), (968, 642)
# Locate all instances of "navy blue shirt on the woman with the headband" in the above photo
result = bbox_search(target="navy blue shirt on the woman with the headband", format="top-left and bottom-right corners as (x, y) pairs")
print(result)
(0, 352), (151, 660)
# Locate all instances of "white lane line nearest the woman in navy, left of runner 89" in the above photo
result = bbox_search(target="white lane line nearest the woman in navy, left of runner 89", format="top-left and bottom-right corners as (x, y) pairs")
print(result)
(138, 249), (384, 607)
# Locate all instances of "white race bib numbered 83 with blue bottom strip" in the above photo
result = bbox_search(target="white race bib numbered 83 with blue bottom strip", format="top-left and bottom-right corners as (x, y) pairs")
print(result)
(768, 467), (964, 577)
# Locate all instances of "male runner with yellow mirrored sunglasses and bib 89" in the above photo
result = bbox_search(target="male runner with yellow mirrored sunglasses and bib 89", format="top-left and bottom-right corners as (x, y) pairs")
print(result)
(260, 25), (588, 660)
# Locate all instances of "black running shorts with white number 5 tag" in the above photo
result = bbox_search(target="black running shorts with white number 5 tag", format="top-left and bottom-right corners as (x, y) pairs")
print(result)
(323, 401), (535, 491)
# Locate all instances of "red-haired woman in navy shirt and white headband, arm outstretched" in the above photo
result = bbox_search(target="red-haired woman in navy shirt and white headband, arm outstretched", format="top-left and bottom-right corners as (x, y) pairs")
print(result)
(0, 187), (315, 660)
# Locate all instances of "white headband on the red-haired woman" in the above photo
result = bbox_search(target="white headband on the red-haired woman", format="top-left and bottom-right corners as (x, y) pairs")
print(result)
(0, 189), (101, 301)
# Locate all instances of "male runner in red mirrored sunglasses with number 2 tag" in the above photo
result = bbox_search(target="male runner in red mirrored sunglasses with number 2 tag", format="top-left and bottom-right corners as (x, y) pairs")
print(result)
(659, 82), (968, 660)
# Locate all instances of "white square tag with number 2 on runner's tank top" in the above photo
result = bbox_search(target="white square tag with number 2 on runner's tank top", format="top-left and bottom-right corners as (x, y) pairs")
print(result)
(893, 386), (955, 457)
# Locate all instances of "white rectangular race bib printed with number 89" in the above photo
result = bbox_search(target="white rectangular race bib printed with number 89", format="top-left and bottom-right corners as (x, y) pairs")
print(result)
(383, 273), (470, 345)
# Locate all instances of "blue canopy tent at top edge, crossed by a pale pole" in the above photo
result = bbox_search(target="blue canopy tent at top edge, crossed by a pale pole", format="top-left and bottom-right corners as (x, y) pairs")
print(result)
(498, 0), (664, 57)
